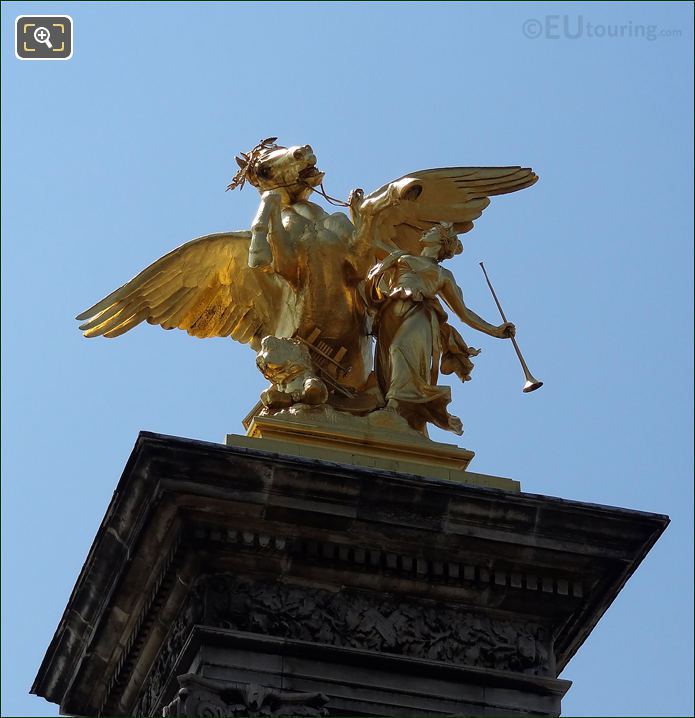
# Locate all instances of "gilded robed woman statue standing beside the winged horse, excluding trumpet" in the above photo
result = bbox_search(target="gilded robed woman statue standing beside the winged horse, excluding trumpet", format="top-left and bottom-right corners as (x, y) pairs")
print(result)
(364, 222), (515, 434)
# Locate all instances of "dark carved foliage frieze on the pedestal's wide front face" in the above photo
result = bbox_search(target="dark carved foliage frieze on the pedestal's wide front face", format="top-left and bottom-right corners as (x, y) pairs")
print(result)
(205, 575), (550, 675)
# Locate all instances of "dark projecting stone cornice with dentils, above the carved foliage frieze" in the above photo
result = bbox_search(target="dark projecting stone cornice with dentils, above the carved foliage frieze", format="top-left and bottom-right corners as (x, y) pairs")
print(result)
(32, 432), (668, 714)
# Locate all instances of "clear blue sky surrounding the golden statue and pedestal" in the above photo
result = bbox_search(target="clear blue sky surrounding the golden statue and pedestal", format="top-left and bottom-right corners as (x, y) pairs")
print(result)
(2, 2), (693, 716)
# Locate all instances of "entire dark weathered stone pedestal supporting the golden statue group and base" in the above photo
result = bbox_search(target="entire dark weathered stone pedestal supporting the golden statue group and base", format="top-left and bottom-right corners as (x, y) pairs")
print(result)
(32, 433), (668, 716)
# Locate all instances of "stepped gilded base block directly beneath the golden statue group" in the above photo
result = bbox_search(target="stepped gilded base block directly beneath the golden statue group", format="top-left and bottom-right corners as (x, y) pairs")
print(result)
(225, 405), (521, 492)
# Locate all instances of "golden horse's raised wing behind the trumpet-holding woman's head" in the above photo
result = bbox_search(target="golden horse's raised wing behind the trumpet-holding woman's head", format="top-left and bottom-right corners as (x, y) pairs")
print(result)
(359, 167), (538, 254)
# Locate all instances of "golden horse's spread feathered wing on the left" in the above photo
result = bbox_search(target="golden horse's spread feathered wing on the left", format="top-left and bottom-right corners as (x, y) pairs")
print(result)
(72, 231), (289, 348)
